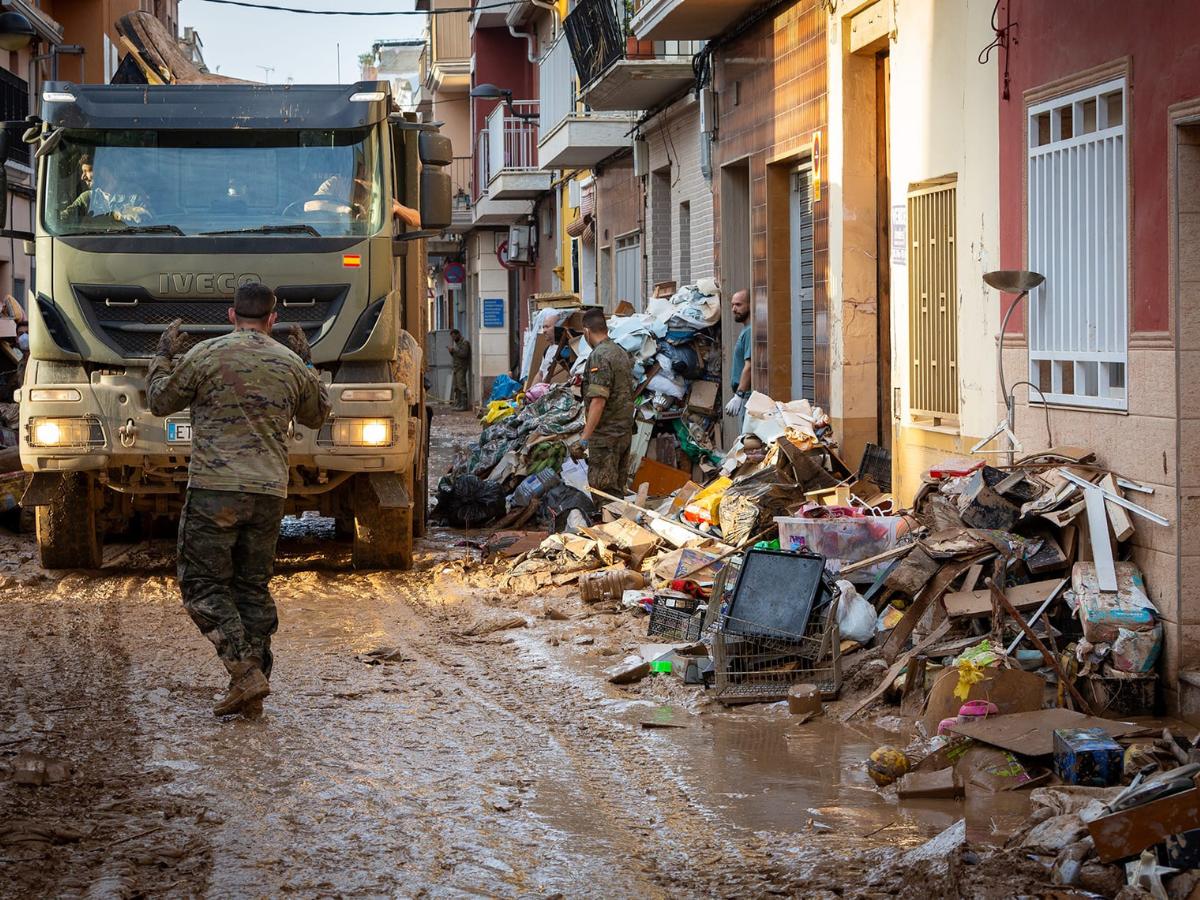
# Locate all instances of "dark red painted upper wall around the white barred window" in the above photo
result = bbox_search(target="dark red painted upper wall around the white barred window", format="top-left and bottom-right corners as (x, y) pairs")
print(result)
(997, 0), (1200, 336)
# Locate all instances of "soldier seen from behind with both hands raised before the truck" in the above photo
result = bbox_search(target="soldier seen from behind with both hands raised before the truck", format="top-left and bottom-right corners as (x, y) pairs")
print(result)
(146, 282), (330, 716)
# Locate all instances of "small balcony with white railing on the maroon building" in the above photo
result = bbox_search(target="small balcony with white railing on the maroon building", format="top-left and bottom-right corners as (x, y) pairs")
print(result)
(474, 100), (553, 224)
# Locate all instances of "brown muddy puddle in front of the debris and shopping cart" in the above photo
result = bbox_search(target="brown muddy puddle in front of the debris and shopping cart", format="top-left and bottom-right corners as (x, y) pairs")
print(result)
(518, 635), (1030, 846)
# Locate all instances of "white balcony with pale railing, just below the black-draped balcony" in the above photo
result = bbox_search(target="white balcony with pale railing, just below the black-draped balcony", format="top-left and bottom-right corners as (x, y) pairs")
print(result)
(538, 34), (635, 169)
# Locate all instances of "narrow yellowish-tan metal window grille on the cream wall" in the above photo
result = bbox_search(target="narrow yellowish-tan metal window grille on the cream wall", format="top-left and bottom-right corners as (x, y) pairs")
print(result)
(908, 181), (959, 421)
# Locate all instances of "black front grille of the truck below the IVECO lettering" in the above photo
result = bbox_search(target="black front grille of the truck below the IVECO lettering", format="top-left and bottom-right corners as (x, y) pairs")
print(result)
(74, 284), (350, 358)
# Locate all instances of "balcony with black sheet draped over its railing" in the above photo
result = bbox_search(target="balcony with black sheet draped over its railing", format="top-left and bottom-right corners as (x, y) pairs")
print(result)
(563, 0), (704, 109)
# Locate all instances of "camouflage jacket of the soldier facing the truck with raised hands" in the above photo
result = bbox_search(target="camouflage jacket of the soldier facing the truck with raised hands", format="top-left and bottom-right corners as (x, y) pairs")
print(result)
(146, 331), (330, 497)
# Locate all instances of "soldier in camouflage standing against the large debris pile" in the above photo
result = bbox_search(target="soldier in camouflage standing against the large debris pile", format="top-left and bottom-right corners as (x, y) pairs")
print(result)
(581, 310), (634, 497)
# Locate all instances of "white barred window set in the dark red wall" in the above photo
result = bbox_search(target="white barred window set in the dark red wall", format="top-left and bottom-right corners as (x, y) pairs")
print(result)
(1027, 78), (1129, 409)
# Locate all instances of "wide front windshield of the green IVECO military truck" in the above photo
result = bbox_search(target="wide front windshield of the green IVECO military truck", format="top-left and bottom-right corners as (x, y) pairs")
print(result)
(42, 128), (383, 236)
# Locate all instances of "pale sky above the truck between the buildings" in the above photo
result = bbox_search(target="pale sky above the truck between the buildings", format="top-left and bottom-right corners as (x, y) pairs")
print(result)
(179, 0), (425, 84)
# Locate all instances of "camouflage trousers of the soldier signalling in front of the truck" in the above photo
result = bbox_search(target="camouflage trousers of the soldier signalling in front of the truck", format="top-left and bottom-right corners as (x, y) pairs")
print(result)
(178, 488), (283, 674)
